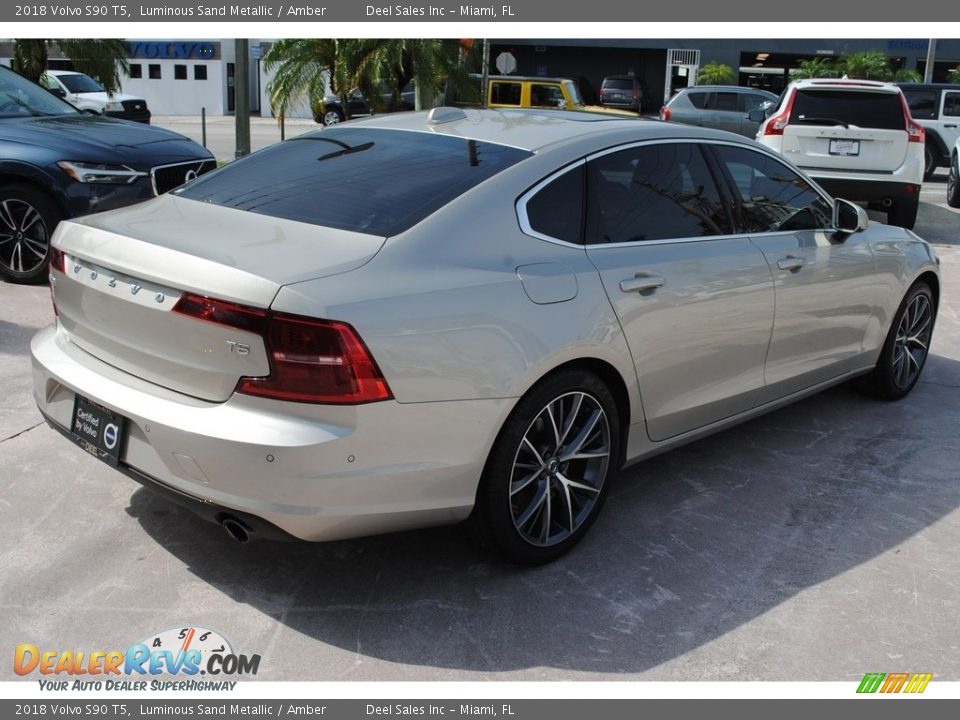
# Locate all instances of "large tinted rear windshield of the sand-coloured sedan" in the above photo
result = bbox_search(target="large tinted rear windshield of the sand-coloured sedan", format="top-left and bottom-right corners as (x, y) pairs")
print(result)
(177, 127), (532, 236)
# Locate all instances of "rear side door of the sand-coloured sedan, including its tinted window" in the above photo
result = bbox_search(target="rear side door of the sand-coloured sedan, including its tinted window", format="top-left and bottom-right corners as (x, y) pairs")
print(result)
(585, 141), (774, 441)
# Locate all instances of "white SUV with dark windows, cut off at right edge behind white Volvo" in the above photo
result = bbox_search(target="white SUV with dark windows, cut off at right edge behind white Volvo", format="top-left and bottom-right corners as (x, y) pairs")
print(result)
(900, 83), (960, 180)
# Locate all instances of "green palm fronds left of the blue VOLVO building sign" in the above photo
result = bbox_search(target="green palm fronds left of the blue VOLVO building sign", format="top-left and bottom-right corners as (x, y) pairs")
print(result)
(13, 38), (129, 94)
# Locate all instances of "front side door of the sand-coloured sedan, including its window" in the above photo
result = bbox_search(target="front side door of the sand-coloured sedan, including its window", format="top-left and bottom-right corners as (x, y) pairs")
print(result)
(711, 145), (879, 403)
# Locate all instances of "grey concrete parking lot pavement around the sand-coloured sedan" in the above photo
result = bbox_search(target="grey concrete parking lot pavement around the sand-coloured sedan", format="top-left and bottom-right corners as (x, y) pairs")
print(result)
(0, 166), (960, 683)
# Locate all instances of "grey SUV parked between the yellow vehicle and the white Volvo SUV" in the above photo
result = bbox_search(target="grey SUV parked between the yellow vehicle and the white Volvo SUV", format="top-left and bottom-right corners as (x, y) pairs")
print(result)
(660, 85), (777, 138)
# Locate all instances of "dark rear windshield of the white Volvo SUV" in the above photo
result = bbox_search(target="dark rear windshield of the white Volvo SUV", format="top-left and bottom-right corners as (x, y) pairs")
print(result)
(790, 90), (906, 130)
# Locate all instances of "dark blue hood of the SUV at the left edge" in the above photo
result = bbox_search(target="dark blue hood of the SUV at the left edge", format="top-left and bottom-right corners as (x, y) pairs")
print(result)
(0, 114), (212, 165)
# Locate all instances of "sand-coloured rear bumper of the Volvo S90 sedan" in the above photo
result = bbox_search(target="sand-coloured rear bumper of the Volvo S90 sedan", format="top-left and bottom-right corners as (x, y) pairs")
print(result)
(31, 326), (512, 541)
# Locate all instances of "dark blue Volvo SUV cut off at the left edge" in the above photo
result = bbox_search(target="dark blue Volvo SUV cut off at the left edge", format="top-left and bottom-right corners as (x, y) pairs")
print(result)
(0, 67), (217, 283)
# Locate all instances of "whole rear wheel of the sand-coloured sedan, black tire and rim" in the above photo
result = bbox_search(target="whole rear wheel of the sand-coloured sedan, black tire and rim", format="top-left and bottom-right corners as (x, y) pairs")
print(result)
(473, 370), (620, 565)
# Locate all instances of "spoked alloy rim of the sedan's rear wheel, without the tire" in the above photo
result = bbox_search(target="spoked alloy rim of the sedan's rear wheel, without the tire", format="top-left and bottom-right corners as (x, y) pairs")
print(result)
(510, 391), (611, 547)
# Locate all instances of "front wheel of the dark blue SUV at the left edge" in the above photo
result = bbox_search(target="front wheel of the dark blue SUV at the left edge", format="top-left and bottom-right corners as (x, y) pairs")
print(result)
(0, 183), (62, 283)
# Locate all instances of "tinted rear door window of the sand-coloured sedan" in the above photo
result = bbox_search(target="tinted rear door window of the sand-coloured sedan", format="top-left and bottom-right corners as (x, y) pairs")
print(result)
(587, 143), (730, 243)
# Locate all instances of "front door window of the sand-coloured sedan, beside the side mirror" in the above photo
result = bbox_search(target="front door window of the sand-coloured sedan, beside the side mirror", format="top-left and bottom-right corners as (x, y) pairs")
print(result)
(713, 145), (833, 233)
